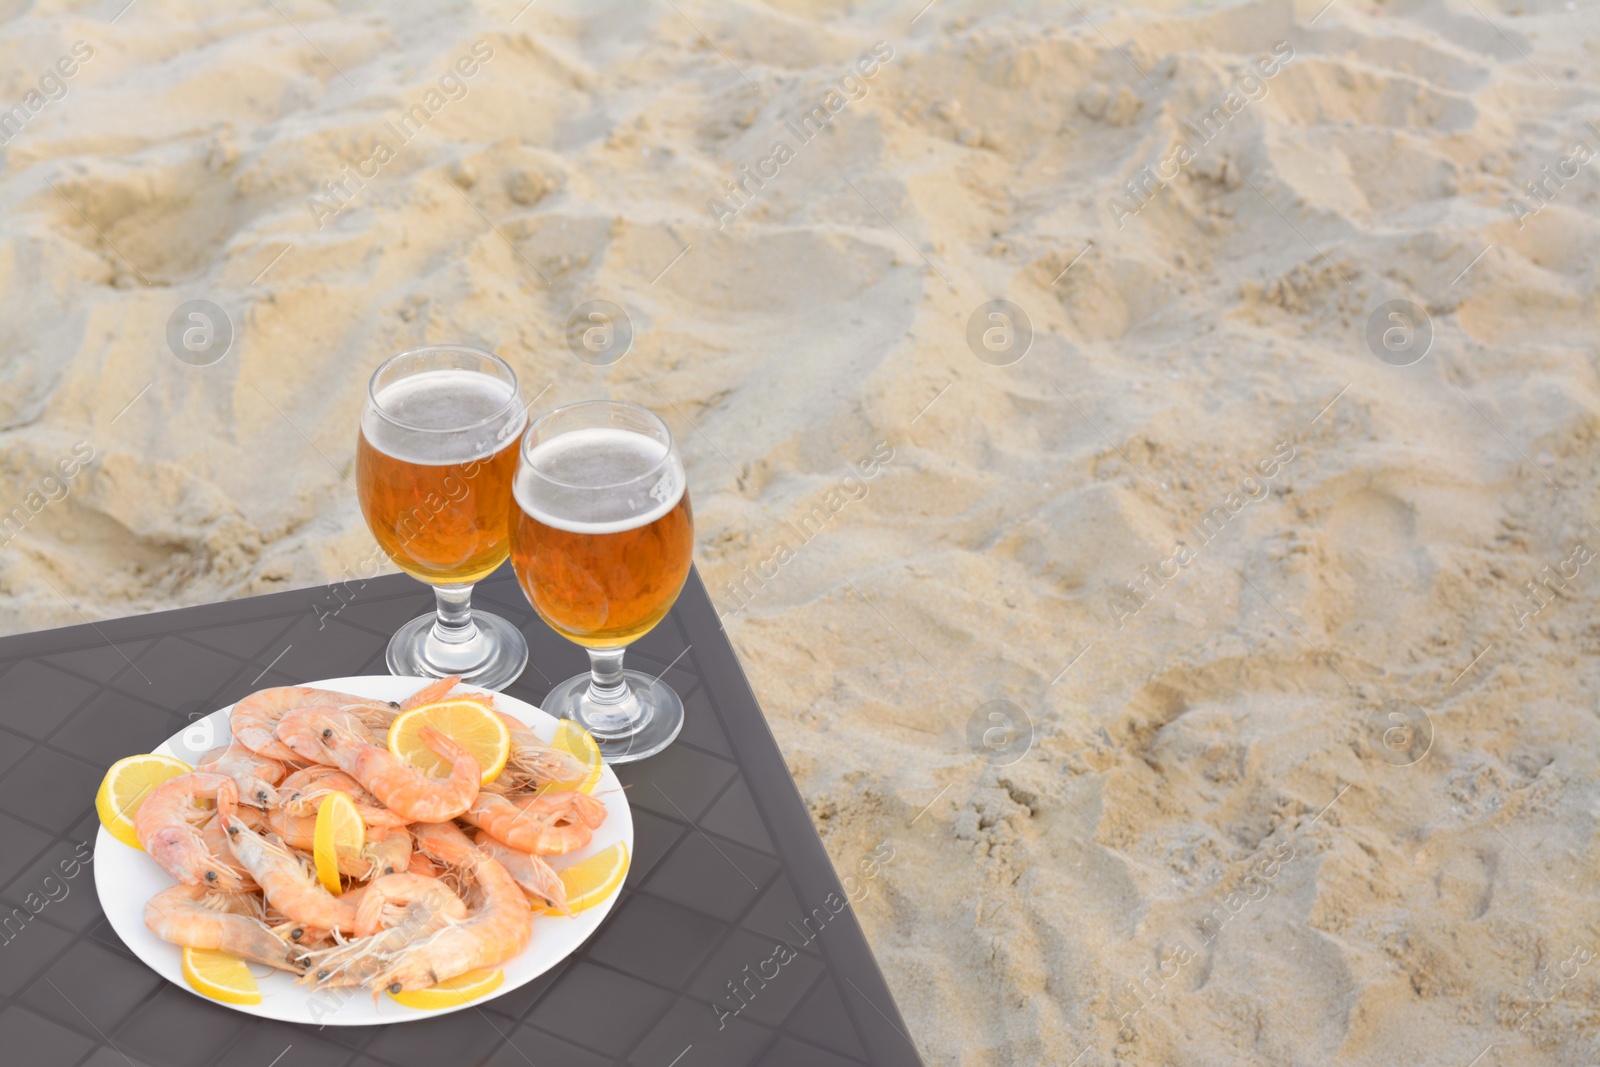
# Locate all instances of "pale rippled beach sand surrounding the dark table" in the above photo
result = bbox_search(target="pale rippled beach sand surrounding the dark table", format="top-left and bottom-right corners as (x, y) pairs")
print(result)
(0, 0), (1600, 1067)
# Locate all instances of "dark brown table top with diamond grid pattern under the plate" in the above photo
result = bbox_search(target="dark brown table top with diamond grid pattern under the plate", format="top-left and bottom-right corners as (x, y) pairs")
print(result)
(0, 568), (920, 1067)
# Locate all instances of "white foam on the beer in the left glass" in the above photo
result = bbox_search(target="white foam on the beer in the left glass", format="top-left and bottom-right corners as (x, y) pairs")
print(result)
(362, 370), (526, 466)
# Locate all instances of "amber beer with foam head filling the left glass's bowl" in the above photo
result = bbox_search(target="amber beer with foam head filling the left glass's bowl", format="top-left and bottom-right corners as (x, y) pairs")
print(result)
(355, 370), (526, 585)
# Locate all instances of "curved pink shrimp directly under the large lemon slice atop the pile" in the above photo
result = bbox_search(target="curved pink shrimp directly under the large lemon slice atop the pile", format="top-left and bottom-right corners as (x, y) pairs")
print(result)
(278, 710), (482, 822)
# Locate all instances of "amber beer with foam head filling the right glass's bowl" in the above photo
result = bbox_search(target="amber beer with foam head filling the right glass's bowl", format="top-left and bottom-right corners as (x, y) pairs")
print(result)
(510, 427), (694, 648)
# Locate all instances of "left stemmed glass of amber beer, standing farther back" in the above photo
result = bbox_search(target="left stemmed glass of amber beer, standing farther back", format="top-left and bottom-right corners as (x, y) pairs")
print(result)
(355, 344), (528, 689)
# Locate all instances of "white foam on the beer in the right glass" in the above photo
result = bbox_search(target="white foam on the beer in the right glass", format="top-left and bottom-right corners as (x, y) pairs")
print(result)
(512, 426), (688, 534)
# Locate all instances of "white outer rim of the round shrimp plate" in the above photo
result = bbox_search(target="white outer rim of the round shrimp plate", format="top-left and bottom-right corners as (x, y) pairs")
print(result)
(91, 675), (635, 1027)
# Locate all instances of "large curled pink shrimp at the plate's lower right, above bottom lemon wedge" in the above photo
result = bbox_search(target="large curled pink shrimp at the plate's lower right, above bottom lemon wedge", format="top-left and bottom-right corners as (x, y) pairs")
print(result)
(315, 822), (533, 993)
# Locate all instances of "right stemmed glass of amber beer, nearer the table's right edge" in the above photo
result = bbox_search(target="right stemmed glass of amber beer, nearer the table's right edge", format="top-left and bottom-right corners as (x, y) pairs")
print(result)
(510, 400), (694, 763)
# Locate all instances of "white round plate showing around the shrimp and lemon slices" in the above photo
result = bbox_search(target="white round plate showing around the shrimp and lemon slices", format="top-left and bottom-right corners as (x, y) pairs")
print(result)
(93, 675), (634, 1027)
